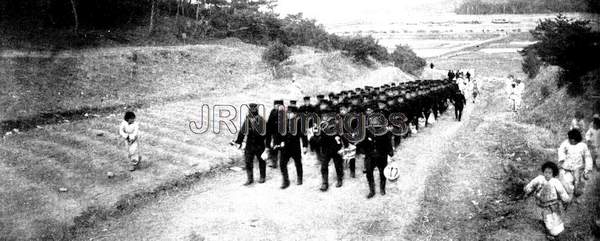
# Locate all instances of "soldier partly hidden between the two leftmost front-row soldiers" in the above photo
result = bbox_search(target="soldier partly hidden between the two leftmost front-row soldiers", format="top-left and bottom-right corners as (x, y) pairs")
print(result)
(266, 100), (285, 168)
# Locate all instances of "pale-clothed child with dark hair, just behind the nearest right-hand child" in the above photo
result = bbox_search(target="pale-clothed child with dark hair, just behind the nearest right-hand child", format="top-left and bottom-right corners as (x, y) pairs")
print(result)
(558, 129), (592, 202)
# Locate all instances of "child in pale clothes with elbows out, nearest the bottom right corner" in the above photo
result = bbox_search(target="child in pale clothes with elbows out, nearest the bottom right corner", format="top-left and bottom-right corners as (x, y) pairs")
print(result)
(525, 162), (571, 240)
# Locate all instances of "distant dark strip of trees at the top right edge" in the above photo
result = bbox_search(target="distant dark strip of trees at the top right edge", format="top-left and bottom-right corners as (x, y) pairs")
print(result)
(455, 0), (600, 14)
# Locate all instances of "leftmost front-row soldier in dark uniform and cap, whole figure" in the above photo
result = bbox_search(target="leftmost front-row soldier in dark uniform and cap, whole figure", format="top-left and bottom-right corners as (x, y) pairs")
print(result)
(235, 103), (267, 186)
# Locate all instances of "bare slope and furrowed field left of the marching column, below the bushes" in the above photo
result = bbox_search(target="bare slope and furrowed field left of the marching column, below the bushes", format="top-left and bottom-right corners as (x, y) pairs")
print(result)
(0, 39), (412, 240)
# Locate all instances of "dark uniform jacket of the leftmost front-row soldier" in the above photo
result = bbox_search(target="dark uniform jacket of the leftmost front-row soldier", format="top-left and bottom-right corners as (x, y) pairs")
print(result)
(235, 115), (265, 153)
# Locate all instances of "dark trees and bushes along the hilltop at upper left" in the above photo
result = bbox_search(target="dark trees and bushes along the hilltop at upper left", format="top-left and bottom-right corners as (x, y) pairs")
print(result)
(0, 0), (425, 74)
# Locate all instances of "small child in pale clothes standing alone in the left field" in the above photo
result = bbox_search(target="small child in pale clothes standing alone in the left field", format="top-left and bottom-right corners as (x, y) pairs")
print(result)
(119, 111), (142, 171)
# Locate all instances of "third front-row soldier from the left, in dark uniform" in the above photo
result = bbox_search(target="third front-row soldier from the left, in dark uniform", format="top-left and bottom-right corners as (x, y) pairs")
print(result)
(310, 107), (344, 192)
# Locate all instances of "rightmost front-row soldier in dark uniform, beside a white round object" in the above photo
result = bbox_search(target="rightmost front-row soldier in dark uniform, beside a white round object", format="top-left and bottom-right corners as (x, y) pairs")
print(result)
(357, 114), (394, 198)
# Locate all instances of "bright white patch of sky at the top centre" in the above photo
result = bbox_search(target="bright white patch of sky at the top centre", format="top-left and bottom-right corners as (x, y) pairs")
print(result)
(276, 0), (460, 25)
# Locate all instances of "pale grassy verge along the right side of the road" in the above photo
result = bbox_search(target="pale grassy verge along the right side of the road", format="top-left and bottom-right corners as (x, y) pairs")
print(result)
(411, 34), (600, 241)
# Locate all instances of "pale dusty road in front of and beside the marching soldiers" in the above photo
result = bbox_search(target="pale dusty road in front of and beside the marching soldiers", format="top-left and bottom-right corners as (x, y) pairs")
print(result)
(79, 104), (470, 240)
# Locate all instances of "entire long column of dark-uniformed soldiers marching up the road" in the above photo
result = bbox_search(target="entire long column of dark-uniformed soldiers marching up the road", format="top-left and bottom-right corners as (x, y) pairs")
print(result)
(232, 80), (466, 198)
